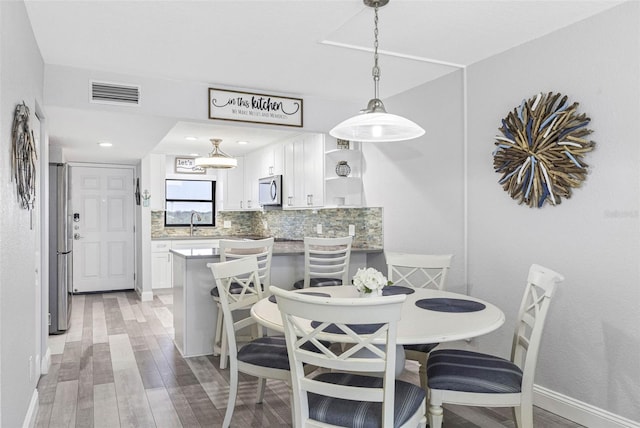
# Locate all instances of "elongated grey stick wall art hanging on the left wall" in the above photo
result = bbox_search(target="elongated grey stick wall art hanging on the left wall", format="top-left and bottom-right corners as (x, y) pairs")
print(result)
(11, 101), (37, 210)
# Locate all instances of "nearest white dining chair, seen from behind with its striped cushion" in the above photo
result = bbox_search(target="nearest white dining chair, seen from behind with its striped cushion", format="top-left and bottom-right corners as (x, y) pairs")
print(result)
(271, 286), (426, 428)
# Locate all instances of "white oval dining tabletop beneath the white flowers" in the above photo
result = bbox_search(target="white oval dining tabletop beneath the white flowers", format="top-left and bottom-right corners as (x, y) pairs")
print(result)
(251, 285), (505, 345)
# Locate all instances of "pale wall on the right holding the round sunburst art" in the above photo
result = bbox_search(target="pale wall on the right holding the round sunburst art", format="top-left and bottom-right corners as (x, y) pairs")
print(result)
(468, 2), (640, 421)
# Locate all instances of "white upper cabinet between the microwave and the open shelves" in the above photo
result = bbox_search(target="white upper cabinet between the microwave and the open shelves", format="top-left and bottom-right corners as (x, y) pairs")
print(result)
(282, 134), (324, 209)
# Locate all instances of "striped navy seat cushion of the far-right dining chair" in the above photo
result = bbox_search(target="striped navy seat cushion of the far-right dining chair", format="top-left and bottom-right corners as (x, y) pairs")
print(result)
(427, 349), (522, 393)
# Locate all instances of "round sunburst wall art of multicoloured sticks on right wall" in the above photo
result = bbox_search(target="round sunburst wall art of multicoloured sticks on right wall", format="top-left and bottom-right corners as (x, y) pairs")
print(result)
(493, 92), (596, 208)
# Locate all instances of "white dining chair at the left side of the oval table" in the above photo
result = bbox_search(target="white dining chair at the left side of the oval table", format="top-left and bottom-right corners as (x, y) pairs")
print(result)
(207, 256), (291, 428)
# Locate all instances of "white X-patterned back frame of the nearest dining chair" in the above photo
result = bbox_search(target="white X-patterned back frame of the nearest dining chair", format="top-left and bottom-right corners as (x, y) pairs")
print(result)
(271, 287), (406, 426)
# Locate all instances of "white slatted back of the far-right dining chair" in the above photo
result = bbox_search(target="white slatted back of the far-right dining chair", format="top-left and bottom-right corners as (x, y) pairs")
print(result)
(511, 264), (564, 394)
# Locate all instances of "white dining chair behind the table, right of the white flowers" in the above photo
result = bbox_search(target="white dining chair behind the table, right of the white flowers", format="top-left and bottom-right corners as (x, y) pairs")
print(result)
(385, 251), (453, 388)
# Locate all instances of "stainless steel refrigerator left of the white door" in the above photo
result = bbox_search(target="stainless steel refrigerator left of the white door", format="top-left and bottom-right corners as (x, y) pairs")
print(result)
(49, 163), (73, 334)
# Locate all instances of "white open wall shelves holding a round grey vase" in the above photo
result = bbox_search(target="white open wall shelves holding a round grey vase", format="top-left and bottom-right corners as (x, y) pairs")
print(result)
(324, 136), (363, 207)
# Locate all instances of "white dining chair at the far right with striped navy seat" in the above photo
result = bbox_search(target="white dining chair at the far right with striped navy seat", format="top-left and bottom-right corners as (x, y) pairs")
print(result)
(427, 264), (564, 428)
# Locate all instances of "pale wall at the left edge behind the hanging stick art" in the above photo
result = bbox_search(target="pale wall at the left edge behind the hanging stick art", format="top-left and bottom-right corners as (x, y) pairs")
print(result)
(0, 2), (46, 427)
